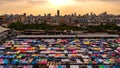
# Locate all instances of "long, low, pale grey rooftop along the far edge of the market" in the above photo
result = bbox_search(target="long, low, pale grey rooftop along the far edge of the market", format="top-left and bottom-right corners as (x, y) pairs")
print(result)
(17, 34), (119, 38)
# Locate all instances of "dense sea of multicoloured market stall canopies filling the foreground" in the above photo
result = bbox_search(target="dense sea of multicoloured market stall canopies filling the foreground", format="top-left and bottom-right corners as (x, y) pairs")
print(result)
(0, 38), (120, 68)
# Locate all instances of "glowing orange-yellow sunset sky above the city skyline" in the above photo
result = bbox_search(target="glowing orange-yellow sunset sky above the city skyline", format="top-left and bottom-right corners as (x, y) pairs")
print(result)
(0, 0), (120, 15)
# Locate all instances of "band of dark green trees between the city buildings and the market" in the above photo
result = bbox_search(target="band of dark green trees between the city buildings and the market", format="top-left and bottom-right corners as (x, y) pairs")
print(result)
(9, 23), (120, 31)
